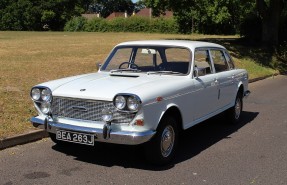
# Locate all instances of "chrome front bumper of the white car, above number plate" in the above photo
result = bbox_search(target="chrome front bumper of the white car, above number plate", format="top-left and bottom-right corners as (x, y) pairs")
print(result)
(30, 116), (156, 145)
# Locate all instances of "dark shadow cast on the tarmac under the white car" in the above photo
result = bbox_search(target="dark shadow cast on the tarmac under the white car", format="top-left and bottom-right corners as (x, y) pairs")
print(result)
(52, 112), (258, 171)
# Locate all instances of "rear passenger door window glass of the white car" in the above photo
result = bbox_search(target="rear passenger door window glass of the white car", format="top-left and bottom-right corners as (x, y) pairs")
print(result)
(210, 50), (229, 73)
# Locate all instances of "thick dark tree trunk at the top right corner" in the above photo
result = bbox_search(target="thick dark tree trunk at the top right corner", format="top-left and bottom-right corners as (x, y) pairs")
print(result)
(256, 0), (284, 45)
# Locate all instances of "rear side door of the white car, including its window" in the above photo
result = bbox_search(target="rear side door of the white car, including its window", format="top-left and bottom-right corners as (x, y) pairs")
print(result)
(210, 49), (236, 109)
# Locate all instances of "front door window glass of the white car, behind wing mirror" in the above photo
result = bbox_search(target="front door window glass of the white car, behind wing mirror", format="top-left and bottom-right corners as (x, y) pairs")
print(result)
(194, 50), (212, 76)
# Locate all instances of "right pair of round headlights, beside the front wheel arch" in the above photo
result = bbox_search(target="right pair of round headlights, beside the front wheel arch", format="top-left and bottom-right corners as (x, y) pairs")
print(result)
(113, 94), (142, 113)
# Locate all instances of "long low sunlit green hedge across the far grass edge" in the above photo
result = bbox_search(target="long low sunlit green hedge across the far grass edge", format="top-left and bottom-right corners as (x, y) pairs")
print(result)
(64, 17), (178, 33)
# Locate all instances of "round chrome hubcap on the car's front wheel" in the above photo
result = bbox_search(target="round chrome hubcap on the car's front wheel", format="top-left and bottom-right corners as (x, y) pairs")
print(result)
(161, 126), (175, 157)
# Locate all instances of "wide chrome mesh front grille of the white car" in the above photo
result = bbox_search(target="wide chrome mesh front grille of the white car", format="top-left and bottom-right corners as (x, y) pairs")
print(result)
(51, 97), (135, 123)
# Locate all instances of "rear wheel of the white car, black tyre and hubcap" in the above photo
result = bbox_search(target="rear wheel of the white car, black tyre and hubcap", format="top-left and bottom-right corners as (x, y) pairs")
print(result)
(226, 93), (243, 124)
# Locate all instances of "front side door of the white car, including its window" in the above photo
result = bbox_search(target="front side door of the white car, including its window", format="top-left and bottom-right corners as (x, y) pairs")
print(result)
(192, 48), (218, 121)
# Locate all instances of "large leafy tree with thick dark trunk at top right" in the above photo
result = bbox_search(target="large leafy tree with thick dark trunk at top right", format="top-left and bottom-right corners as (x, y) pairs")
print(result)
(145, 0), (287, 45)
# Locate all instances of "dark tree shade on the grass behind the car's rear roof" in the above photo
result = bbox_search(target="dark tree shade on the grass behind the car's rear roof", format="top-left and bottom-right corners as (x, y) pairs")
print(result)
(168, 38), (287, 74)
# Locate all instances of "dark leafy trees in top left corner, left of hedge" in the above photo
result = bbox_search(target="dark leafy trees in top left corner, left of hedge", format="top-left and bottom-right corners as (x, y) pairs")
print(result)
(0, 0), (84, 31)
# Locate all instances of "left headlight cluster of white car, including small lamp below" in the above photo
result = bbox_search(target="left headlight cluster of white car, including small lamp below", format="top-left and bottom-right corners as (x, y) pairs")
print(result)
(30, 86), (52, 114)
